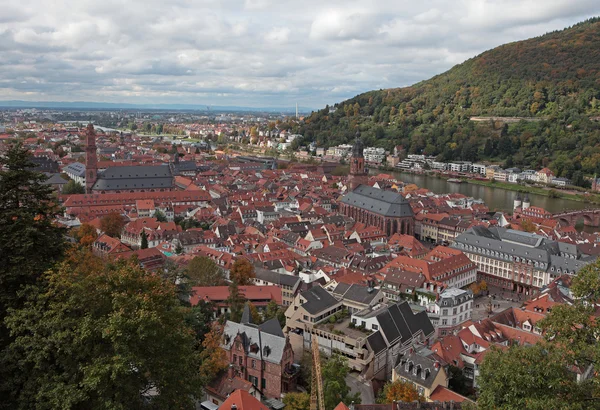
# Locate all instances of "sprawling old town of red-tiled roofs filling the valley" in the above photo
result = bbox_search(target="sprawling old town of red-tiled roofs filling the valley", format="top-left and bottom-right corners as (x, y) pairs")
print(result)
(0, 114), (600, 410)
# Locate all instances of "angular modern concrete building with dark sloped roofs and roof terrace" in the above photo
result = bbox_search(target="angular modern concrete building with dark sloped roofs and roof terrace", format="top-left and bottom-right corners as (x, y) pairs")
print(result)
(285, 285), (434, 380)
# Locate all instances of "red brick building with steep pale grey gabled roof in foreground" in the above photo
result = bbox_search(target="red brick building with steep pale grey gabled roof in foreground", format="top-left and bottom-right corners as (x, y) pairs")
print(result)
(222, 304), (298, 399)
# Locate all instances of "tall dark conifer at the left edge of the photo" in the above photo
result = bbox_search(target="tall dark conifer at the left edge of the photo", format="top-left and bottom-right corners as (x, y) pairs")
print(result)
(0, 143), (65, 408)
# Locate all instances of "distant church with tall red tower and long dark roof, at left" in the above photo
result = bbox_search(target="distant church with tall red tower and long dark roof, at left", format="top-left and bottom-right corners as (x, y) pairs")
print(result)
(85, 123), (175, 194)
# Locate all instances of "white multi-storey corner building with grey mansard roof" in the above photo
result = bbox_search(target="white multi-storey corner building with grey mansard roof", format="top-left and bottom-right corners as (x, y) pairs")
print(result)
(427, 288), (473, 337)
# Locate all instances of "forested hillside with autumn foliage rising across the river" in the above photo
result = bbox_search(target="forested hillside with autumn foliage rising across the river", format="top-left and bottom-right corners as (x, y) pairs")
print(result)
(300, 18), (600, 186)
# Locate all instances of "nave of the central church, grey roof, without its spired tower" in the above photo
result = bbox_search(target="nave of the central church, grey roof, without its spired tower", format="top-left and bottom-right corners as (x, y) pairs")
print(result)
(339, 185), (415, 237)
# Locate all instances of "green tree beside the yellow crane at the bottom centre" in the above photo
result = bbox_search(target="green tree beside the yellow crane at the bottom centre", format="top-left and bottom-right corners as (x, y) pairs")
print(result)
(321, 354), (360, 410)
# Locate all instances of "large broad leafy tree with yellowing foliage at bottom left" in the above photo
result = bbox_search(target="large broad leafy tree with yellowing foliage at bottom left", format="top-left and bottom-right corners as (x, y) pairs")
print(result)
(7, 250), (200, 409)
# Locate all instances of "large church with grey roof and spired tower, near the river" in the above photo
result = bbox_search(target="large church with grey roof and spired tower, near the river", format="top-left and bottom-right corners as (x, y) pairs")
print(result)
(339, 134), (415, 236)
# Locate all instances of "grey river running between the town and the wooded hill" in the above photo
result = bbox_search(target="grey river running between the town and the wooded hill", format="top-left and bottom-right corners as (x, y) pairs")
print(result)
(372, 170), (590, 213)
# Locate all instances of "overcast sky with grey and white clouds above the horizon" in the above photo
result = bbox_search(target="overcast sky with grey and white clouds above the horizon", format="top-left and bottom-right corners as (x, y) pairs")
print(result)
(0, 0), (600, 108)
